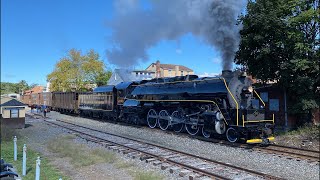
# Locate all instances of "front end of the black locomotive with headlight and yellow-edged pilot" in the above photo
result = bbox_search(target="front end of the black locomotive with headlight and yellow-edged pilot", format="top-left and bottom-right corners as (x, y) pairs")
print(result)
(226, 71), (274, 143)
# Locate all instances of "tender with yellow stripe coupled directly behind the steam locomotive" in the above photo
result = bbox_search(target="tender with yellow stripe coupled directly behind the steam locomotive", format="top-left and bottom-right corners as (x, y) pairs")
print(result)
(79, 86), (117, 119)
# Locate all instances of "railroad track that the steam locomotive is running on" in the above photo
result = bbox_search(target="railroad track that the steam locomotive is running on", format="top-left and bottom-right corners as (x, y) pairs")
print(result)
(29, 113), (320, 164)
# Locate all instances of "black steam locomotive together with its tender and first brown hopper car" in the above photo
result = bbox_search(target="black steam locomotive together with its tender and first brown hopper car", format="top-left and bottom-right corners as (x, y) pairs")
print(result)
(23, 71), (274, 143)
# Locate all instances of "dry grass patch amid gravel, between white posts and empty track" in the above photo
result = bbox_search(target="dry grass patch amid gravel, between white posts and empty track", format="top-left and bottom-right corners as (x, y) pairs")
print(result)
(47, 136), (116, 168)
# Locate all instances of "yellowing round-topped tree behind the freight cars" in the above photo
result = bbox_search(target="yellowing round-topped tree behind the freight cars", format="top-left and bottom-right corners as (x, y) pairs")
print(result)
(47, 49), (112, 91)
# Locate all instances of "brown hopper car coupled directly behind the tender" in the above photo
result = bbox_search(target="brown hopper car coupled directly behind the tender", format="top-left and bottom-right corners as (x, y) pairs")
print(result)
(51, 92), (79, 113)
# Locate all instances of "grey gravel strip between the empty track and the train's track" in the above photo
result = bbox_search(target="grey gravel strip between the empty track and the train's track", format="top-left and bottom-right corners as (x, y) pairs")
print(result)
(23, 111), (319, 179)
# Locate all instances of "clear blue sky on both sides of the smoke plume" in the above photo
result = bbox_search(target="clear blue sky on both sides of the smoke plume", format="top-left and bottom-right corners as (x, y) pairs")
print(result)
(1, 0), (232, 85)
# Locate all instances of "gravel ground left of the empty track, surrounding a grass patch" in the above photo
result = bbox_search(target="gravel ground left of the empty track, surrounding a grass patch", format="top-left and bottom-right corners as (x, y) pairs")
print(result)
(18, 114), (182, 180)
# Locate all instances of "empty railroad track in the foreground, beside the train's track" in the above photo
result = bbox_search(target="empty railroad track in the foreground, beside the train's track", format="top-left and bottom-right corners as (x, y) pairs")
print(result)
(45, 120), (281, 179)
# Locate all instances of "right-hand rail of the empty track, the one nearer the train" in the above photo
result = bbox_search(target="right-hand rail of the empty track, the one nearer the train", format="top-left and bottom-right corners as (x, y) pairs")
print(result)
(47, 119), (282, 179)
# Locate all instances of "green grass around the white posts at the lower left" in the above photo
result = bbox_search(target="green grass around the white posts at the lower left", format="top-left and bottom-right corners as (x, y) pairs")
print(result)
(1, 128), (69, 180)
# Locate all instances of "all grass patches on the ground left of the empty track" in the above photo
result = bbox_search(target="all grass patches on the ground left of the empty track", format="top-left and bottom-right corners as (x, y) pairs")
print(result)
(1, 128), (164, 180)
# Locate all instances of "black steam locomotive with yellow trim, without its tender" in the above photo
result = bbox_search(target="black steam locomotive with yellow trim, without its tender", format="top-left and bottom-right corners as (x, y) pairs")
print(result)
(122, 71), (274, 143)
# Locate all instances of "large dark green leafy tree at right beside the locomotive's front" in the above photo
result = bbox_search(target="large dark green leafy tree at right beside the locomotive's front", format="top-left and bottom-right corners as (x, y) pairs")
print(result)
(235, 0), (320, 122)
